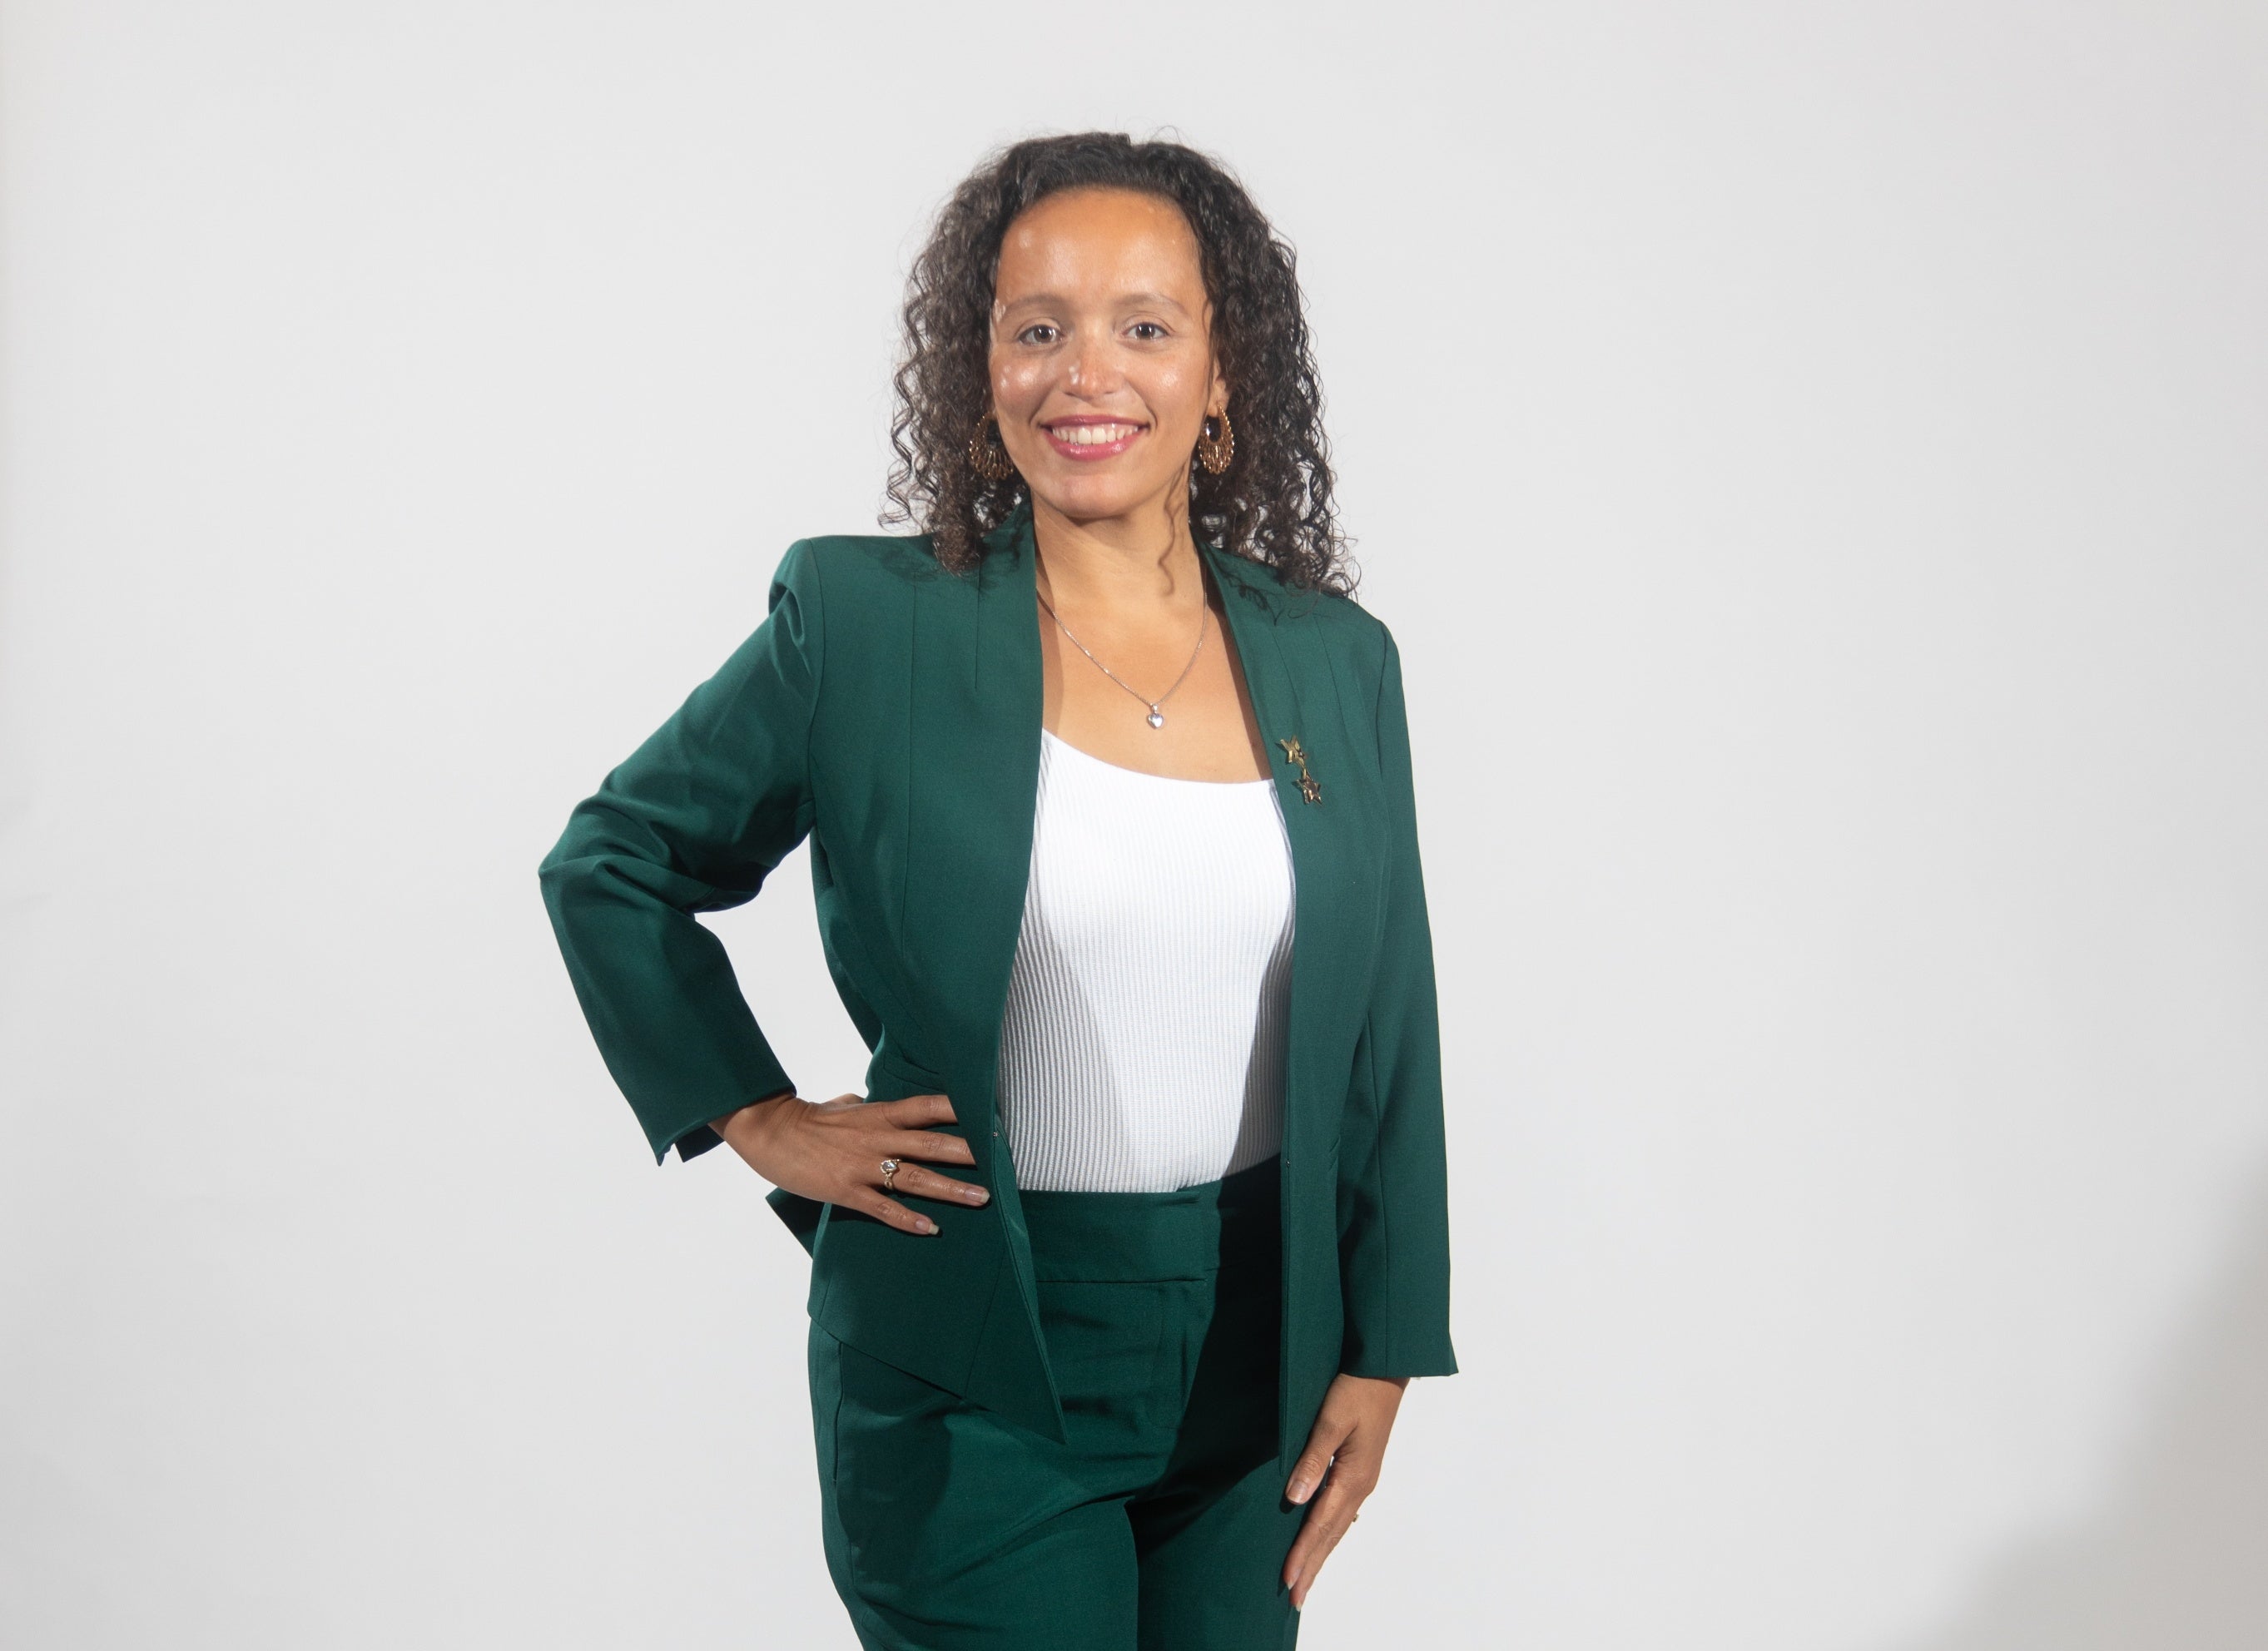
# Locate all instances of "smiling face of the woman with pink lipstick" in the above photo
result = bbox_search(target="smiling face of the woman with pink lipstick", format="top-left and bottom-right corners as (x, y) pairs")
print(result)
(991, 188), (1229, 524)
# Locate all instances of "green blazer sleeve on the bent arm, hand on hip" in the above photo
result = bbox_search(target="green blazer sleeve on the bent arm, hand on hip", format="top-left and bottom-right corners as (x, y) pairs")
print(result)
(540, 542), (821, 1163)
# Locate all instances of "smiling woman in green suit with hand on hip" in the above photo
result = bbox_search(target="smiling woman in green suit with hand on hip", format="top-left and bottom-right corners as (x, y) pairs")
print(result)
(542, 134), (1456, 1651)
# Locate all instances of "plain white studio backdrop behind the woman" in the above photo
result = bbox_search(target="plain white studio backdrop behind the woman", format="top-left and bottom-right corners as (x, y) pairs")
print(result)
(0, 0), (2268, 1651)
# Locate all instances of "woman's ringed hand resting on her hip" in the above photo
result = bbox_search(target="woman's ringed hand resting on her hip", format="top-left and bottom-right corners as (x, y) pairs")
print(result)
(710, 1095), (991, 1234)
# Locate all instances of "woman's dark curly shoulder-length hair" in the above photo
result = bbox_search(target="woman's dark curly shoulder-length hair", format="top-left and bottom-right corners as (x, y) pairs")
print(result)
(882, 131), (1357, 594)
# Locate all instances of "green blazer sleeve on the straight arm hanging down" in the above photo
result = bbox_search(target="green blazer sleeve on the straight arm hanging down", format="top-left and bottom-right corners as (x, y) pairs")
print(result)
(1338, 635), (1456, 1376)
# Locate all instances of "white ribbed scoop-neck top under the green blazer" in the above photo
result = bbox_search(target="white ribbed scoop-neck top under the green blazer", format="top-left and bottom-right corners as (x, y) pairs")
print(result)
(1000, 731), (1293, 1192)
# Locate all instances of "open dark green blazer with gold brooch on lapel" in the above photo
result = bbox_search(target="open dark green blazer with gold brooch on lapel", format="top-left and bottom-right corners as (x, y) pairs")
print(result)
(542, 508), (1456, 1467)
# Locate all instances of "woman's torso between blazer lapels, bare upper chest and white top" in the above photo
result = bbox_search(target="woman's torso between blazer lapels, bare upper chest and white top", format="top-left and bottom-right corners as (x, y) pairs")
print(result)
(1015, 517), (1293, 1192)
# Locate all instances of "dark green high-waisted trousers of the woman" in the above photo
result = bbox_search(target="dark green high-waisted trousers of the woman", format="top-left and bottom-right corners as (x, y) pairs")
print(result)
(810, 1159), (1304, 1651)
